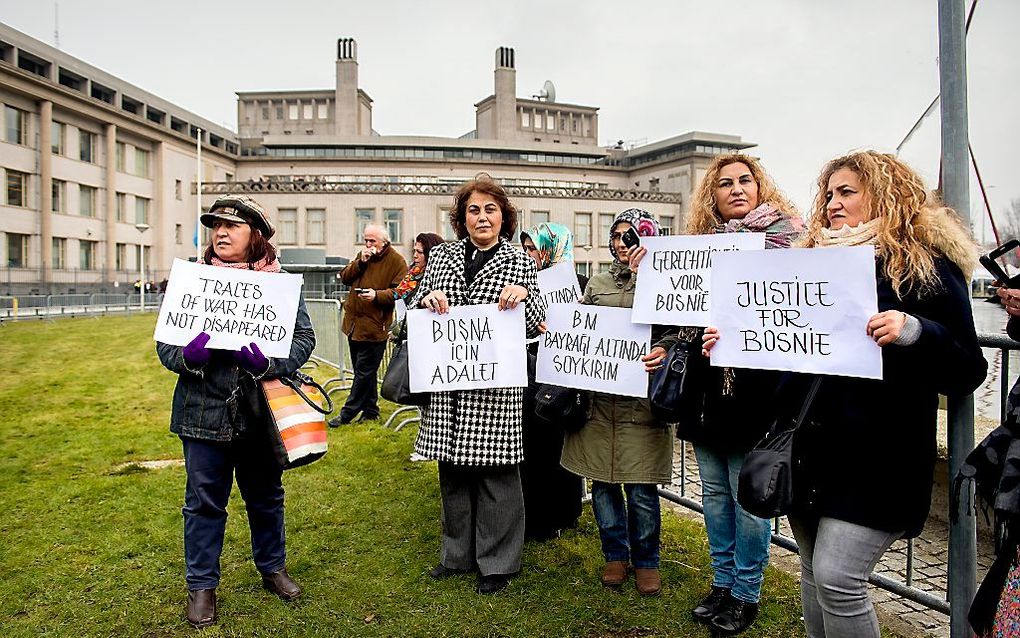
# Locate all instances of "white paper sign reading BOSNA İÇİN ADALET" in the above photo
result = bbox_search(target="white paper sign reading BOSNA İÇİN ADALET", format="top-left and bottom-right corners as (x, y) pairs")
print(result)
(407, 303), (527, 392)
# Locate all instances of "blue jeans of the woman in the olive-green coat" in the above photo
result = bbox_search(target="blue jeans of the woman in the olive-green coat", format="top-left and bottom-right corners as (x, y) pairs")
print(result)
(592, 481), (662, 569)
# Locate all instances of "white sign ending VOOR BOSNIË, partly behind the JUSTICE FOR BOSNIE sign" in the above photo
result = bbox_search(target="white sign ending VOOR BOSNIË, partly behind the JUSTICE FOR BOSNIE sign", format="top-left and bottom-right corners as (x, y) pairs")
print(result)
(631, 233), (765, 326)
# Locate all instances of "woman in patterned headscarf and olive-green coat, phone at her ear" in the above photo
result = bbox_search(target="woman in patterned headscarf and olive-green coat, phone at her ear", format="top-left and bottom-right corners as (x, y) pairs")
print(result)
(560, 208), (673, 595)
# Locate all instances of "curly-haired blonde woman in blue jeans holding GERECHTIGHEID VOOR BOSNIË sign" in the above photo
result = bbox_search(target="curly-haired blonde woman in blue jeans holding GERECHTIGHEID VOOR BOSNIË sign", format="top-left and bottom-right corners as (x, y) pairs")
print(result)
(636, 154), (804, 635)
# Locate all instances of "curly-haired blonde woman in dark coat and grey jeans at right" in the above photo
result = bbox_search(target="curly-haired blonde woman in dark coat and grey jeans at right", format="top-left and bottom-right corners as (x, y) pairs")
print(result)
(705, 151), (986, 638)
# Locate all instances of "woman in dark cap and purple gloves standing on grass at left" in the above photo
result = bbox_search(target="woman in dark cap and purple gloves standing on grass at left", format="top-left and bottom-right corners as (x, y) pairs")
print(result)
(156, 195), (315, 627)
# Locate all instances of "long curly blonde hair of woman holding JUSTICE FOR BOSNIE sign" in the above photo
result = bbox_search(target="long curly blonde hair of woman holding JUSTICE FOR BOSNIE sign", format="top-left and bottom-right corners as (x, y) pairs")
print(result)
(800, 150), (978, 298)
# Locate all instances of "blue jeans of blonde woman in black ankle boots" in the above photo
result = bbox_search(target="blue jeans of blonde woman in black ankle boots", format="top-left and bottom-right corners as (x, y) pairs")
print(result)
(695, 445), (772, 602)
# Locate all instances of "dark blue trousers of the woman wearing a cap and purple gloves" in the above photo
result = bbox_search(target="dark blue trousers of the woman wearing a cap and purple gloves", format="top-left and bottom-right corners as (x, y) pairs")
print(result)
(181, 437), (287, 590)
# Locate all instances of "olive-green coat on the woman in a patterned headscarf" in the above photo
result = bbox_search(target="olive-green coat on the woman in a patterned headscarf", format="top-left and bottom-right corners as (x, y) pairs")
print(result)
(560, 262), (674, 484)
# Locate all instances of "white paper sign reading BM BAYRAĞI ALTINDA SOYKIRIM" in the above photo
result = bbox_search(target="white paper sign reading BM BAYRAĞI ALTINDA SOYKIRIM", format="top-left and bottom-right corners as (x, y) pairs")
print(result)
(534, 304), (652, 397)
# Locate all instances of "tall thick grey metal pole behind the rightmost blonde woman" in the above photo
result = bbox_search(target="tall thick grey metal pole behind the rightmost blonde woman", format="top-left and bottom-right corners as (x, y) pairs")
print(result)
(938, 0), (977, 638)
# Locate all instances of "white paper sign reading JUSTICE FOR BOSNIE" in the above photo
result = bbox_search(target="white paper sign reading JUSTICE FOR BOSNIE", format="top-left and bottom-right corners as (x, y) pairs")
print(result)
(711, 246), (882, 379)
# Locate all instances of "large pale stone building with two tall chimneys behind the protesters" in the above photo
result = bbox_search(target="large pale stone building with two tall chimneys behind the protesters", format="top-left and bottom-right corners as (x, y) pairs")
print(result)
(0, 24), (753, 294)
